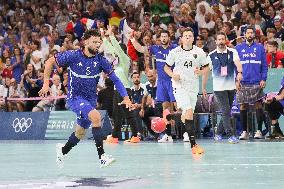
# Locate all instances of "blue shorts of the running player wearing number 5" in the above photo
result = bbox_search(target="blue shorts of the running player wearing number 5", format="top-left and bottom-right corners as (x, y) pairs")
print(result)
(67, 97), (97, 129)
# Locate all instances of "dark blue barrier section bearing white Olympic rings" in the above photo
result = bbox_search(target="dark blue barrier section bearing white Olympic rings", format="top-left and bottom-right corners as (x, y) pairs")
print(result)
(0, 112), (49, 140)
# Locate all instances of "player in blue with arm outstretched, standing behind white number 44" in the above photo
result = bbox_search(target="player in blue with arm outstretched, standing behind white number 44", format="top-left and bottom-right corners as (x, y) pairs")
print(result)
(130, 30), (177, 143)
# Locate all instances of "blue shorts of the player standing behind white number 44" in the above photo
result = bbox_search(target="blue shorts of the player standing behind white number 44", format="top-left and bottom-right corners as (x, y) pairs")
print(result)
(156, 80), (176, 102)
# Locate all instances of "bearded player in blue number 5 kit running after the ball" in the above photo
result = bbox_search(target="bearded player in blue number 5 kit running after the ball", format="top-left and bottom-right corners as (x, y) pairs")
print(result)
(39, 30), (131, 167)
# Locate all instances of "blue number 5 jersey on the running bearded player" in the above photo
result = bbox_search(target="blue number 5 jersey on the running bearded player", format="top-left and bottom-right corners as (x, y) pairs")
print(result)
(55, 49), (112, 101)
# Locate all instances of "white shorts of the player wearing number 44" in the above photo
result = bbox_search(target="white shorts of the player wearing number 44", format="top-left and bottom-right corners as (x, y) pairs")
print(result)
(174, 87), (198, 114)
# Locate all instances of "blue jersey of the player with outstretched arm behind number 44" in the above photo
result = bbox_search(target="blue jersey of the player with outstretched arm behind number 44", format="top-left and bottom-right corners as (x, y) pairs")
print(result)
(150, 44), (177, 81)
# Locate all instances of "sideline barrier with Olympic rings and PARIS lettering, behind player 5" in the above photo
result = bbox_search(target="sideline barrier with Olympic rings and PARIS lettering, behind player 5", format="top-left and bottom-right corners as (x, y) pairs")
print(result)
(0, 110), (112, 140)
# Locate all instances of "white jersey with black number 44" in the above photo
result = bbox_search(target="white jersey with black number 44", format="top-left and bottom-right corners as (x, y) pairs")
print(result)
(166, 45), (208, 93)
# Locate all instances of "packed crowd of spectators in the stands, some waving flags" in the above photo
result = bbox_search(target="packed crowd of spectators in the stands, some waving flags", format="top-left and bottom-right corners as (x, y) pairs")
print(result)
(0, 0), (284, 123)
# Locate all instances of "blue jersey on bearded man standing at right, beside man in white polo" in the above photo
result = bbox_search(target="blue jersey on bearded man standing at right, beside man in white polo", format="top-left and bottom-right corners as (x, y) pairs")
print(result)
(236, 42), (268, 84)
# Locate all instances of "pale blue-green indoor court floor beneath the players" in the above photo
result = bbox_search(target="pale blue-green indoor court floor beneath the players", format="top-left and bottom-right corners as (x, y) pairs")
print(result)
(0, 139), (284, 189)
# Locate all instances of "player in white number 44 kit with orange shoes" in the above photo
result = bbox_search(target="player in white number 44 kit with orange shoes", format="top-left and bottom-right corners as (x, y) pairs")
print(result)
(164, 28), (209, 154)
